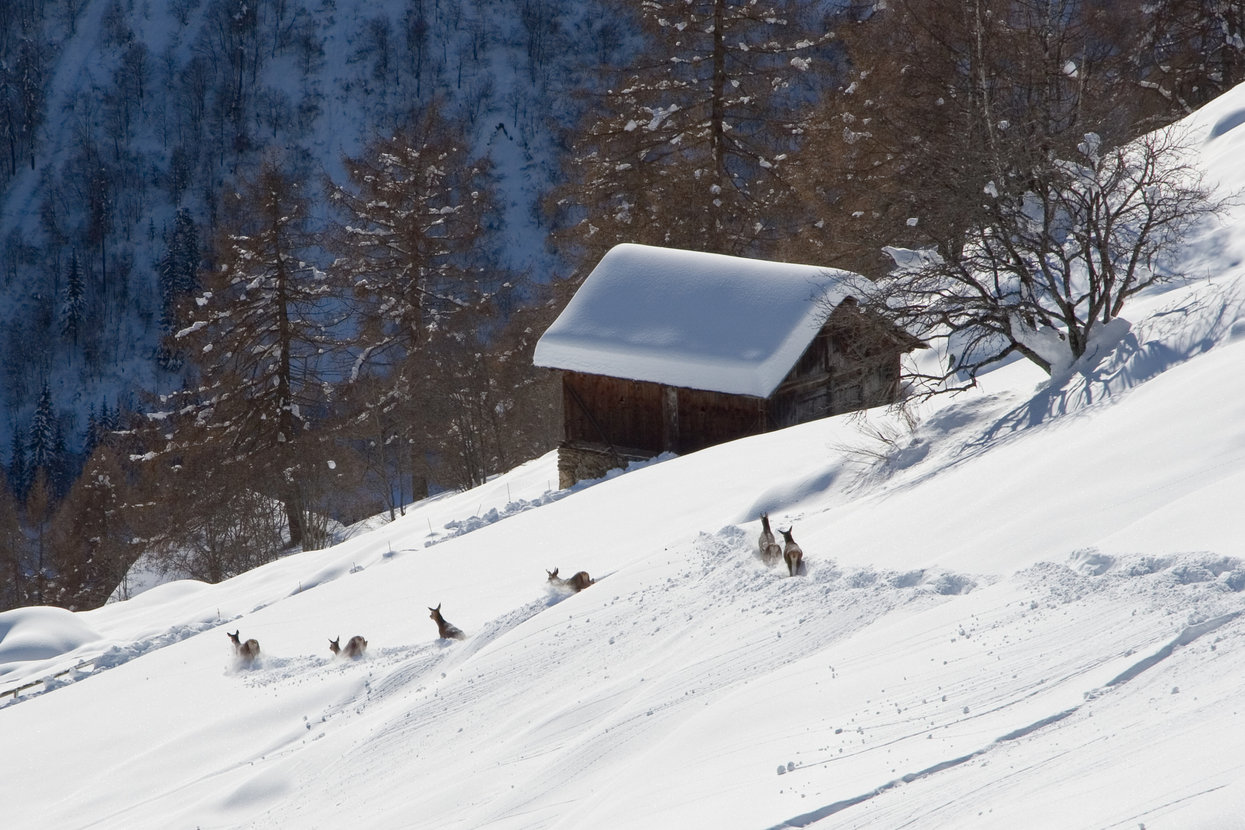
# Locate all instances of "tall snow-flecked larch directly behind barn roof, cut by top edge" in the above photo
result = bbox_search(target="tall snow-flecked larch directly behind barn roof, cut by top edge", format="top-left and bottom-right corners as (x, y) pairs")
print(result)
(550, 0), (832, 263)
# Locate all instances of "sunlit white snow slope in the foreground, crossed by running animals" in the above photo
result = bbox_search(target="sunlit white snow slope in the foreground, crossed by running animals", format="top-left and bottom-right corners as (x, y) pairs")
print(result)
(0, 88), (1245, 830)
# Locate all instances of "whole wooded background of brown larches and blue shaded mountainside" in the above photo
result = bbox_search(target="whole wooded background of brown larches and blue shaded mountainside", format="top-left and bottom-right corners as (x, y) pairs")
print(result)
(0, 0), (1245, 610)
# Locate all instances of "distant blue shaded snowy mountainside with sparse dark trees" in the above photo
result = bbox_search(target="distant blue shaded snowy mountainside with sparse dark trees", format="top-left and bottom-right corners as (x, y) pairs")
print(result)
(0, 0), (612, 460)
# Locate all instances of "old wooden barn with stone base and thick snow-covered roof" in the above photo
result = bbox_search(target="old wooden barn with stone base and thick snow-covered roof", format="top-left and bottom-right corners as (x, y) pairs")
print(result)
(534, 244), (921, 488)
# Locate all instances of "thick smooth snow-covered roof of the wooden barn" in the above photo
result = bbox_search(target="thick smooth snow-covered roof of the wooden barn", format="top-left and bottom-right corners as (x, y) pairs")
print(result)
(533, 244), (860, 397)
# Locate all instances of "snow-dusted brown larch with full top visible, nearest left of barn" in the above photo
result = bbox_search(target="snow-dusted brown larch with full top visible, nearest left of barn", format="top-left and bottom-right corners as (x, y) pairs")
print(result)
(329, 105), (500, 498)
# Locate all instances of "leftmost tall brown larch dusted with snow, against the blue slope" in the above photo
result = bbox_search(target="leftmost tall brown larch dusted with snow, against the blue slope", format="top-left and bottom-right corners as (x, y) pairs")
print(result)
(166, 157), (340, 546)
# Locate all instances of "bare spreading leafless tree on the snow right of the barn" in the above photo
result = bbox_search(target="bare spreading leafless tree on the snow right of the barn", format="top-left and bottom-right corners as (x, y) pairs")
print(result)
(865, 128), (1224, 385)
